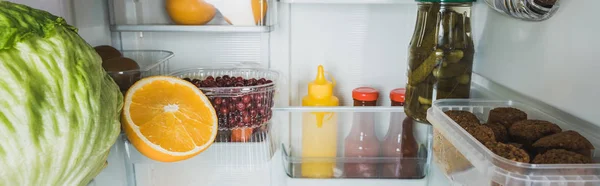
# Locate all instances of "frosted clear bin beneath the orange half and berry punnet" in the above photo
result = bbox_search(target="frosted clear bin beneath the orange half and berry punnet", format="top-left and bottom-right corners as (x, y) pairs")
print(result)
(118, 133), (273, 186)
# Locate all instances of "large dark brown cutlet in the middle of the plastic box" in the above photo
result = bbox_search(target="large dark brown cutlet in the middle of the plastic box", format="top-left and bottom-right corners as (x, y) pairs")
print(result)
(508, 120), (562, 149)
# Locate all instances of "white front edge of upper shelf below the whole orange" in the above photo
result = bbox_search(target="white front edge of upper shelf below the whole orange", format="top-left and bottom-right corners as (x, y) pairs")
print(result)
(110, 25), (272, 33)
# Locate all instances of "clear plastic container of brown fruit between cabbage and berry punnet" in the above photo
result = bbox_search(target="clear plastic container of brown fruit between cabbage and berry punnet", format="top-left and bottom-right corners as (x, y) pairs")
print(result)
(107, 50), (173, 91)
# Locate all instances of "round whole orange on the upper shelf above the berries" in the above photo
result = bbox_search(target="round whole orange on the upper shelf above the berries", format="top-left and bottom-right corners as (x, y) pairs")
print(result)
(166, 0), (217, 25)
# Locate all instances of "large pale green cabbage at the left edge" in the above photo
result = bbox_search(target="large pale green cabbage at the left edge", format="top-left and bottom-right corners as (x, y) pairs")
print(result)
(0, 0), (123, 186)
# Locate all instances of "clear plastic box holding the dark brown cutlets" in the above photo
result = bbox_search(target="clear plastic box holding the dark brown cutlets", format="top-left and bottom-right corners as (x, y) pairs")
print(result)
(427, 99), (600, 186)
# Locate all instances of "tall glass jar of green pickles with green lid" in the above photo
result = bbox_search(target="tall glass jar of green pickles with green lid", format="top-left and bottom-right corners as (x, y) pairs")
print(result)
(404, 0), (475, 122)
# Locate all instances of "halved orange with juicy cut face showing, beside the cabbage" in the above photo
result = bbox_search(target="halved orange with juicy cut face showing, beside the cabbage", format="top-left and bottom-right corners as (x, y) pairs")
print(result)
(122, 76), (218, 162)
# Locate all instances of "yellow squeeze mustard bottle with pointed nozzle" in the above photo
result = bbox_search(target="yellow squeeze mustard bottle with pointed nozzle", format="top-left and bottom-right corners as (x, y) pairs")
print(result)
(302, 65), (339, 178)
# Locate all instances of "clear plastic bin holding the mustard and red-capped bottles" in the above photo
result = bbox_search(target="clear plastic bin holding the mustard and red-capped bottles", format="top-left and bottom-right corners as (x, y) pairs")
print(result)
(273, 106), (432, 180)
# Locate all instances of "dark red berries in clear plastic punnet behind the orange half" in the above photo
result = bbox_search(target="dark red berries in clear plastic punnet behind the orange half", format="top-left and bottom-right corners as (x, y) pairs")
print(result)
(183, 75), (275, 130)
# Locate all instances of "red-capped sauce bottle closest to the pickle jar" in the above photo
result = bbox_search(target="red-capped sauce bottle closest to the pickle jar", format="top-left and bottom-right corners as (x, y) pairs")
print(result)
(381, 88), (421, 179)
